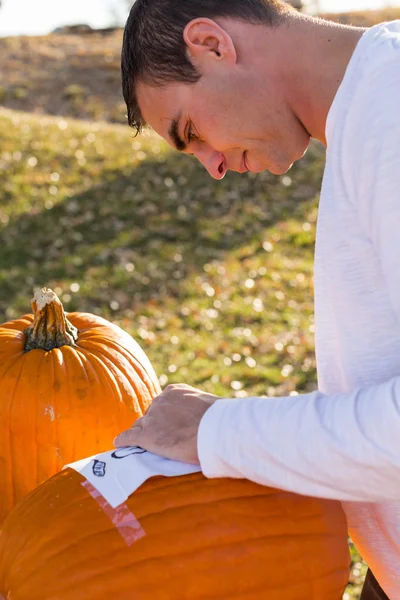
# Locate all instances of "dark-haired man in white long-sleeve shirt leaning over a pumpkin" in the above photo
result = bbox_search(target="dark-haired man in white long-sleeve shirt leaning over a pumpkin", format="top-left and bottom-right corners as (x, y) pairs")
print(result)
(115, 0), (400, 600)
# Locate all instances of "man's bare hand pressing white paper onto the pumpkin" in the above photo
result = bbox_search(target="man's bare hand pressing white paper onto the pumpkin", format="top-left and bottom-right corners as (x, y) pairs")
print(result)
(114, 383), (219, 464)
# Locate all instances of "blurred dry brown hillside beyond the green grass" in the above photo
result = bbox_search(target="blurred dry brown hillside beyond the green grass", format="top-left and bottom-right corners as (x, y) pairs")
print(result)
(0, 8), (400, 123)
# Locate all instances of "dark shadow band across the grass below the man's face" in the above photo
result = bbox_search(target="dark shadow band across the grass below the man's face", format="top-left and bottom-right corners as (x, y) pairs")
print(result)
(0, 146), (323, 316)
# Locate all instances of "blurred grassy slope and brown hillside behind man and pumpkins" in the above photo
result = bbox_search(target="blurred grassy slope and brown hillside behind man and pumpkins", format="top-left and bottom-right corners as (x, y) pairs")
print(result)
(0, 2), (400, 600)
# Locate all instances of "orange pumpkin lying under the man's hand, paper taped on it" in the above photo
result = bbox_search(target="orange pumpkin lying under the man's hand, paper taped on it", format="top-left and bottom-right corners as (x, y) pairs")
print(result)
(0, 469), (350, 600)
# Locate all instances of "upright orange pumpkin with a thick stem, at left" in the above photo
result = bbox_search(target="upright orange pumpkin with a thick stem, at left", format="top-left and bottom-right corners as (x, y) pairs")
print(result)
(0, 289), (160, 523)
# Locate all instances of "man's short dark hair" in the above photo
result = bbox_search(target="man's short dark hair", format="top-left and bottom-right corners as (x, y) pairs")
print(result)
(121, 0), (290, 133)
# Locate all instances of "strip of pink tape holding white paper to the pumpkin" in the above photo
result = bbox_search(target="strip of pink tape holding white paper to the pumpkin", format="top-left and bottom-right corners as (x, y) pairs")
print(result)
(81, 480), (146, 546)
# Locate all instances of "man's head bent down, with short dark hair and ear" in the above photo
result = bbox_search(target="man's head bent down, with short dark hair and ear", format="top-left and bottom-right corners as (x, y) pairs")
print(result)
(122, 0), (360, 179)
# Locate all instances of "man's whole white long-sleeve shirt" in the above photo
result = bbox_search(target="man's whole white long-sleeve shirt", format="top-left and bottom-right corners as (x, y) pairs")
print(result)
(198, 21), (400, 600)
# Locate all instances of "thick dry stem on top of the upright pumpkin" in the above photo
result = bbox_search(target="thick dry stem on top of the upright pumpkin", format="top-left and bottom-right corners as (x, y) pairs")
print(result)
(24, 288), (78, 352)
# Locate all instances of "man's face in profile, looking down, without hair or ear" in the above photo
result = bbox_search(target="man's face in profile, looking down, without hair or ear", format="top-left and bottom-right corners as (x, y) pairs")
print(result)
(137, 39), (310, 179)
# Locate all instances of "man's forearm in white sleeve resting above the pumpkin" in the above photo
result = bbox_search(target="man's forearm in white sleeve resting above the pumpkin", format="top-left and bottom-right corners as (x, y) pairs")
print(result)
(198, 379), (400, 501)
